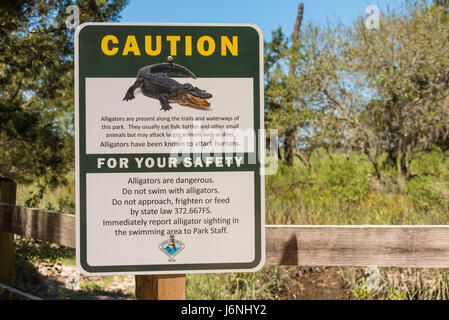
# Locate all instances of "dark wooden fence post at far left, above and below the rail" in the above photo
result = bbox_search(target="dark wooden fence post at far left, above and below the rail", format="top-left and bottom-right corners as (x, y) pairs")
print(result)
(0, 178), (17, 286)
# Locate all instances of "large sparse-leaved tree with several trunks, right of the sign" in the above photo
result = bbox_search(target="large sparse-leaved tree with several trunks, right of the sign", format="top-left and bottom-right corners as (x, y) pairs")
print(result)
(288, 1), (449, 178)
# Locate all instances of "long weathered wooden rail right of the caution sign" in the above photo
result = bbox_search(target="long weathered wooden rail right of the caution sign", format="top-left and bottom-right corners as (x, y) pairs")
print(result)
(266, 226), (449, 268)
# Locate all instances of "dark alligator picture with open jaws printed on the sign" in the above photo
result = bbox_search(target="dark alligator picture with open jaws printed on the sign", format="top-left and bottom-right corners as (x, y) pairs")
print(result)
(123, 59), (212, 111)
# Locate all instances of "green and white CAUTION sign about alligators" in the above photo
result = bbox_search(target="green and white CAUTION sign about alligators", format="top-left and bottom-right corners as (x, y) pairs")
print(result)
(75, 23), (265, 275)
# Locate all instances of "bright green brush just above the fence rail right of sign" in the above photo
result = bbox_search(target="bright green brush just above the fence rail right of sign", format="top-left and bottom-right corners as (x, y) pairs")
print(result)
(266, 150), (449, 225)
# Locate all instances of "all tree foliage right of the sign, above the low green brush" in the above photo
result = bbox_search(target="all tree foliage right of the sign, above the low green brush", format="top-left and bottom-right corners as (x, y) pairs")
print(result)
(265, 0), (449, 178)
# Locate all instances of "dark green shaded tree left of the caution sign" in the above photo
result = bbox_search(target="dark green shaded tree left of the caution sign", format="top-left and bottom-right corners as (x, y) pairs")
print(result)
(0, 0), (126, 182)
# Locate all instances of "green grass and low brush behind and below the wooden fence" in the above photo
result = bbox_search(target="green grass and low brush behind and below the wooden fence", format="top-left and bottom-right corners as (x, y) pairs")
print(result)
(11, 150), (449, 300)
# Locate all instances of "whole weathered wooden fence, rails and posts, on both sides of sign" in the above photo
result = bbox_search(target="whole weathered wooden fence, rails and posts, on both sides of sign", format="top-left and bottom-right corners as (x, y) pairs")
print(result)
(0, 181), (449, 299)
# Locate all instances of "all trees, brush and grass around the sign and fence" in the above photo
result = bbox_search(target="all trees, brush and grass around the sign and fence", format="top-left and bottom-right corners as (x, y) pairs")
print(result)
(6, 0), (449, 300)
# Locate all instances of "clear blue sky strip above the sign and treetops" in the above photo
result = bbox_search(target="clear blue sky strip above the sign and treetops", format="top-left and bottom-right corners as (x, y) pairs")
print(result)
(121, 0), (404, 40)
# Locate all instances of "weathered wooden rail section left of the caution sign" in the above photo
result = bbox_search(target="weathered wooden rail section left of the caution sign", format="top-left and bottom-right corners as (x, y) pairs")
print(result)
(0, 204), (76, 248)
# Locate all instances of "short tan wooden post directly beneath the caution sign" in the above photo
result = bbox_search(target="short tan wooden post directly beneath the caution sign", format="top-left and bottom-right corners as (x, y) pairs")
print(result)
(136, 274), (186, 300)
